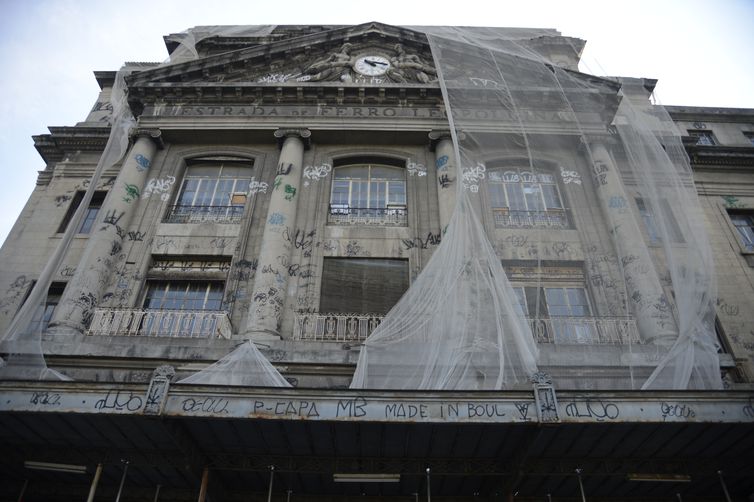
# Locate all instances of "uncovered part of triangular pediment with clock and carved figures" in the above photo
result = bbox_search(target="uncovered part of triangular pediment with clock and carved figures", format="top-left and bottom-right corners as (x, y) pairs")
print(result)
(127, 22), (437, 88)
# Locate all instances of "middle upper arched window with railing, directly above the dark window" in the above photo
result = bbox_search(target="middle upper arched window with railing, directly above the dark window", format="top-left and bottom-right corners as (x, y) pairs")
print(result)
(329, 158), (407, 226)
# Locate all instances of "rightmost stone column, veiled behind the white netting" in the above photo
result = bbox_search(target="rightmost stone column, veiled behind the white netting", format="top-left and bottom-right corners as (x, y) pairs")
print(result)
(589, 135), (678, 345)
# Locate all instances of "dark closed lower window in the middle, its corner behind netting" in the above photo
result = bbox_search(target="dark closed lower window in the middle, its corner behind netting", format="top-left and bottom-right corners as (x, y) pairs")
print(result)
(319, 258), (409, 314)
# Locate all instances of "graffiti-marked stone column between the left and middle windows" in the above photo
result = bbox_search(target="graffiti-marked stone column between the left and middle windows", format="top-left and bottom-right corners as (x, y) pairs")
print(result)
(244, 129), (311, 340)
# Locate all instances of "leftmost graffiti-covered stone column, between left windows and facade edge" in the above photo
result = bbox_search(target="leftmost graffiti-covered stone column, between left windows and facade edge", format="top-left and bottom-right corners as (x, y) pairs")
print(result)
(50, 129), (162, 332)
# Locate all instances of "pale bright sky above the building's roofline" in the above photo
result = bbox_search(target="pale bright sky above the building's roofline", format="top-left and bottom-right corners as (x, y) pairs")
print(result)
(0, 0), (754, 247)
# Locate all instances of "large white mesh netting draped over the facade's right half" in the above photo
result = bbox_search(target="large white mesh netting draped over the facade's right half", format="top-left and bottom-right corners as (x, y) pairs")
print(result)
(352, 28), (721, 389)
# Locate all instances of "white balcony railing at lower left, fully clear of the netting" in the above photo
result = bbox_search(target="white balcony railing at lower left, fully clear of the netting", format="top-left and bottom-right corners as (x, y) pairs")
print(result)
(87, 309), (232, 340)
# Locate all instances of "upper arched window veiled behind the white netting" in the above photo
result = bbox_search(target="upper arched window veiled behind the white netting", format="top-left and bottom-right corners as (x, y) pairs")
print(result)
(487, 168), (569, 228)
